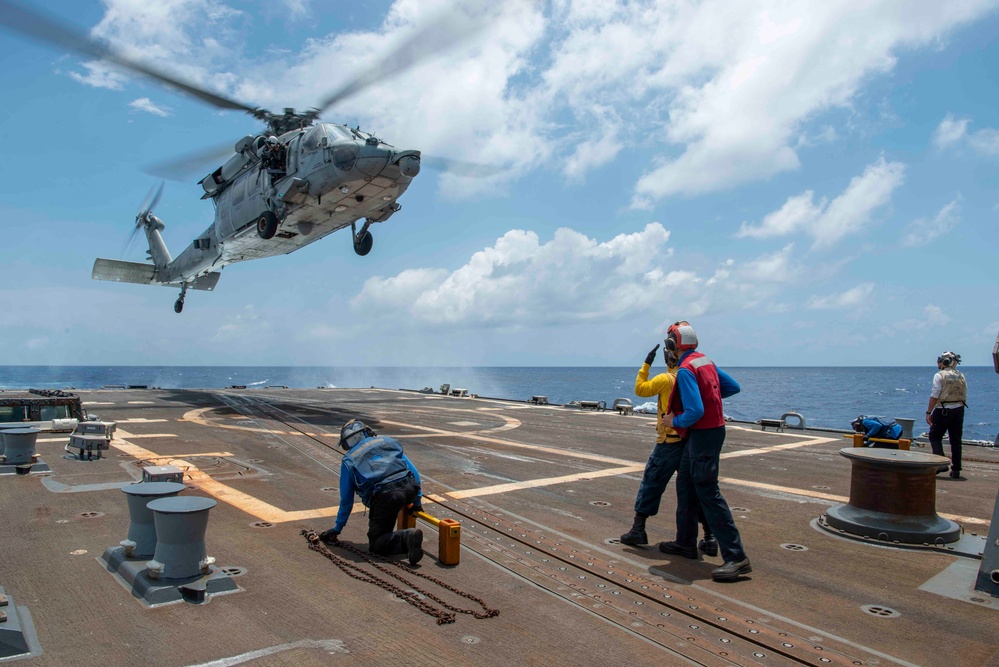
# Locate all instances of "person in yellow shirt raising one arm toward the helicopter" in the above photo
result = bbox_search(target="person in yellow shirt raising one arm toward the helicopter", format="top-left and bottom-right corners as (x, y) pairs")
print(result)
(621, 345), (718, 557)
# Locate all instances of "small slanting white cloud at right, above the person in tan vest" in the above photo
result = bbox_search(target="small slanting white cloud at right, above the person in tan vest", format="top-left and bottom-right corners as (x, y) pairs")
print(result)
(735, 156), (905, 247)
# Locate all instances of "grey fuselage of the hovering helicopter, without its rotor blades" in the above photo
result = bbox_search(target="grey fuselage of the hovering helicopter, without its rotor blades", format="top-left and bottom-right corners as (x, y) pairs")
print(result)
(154, 123), (420, 284)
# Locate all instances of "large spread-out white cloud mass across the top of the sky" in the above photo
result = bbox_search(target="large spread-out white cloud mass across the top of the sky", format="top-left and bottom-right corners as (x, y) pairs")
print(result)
(68, 0), (999, 204)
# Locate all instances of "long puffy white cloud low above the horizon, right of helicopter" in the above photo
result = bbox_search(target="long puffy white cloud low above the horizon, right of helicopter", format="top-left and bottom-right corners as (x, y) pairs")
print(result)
(351, 222), (672, 326)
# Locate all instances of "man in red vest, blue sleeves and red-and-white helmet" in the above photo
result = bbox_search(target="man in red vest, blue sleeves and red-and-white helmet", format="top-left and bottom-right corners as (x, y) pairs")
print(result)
(659, 322), (753, 581)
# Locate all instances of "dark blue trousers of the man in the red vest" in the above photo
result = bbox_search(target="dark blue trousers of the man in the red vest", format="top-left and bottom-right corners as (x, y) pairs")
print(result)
(676, 426), (746, 562)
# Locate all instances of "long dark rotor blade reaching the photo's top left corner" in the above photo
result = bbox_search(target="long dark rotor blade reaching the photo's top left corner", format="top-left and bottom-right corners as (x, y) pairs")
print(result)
(0, 0), (259, 113)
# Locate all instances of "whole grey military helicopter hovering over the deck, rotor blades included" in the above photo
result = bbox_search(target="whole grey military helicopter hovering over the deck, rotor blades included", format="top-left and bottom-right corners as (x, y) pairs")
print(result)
(0, 0), (498, 313)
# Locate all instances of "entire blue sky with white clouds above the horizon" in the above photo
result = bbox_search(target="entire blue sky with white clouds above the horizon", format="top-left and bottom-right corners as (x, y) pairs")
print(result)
(0, 0), (999, 368)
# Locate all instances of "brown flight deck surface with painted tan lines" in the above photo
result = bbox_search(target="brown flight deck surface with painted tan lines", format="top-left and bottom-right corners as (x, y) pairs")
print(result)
(0, 389), (999, 665)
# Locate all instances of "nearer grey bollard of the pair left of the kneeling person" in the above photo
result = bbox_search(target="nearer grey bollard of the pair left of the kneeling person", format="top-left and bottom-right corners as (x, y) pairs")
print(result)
(146, 496), (218, 579)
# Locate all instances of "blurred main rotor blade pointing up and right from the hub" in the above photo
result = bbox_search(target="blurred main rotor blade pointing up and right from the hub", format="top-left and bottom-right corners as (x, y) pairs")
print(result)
(314, 5), (487, 117)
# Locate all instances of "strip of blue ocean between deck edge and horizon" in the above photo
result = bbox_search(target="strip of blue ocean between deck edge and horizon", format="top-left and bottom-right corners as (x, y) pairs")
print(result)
(0, 365), (999, 443)
